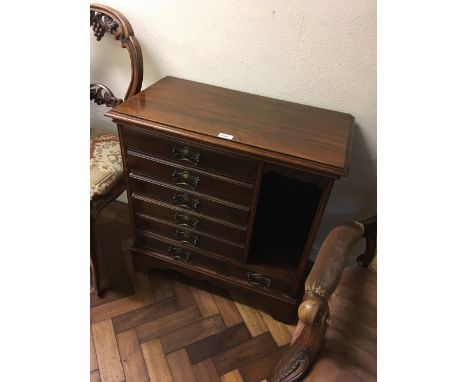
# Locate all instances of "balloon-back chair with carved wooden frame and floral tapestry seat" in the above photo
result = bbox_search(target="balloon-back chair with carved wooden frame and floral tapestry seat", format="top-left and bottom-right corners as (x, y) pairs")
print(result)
(90, 4), (143, 297)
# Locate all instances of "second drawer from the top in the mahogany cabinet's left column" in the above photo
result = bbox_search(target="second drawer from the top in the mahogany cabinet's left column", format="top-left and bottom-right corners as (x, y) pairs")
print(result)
(126, 151), (253, 206)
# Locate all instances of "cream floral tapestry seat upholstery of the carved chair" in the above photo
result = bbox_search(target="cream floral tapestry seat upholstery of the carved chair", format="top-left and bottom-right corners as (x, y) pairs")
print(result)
(90, 129), (123, 200)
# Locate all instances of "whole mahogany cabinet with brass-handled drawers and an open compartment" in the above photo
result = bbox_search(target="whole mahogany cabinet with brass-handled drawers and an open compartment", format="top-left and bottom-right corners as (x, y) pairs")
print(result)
(107, 77), (354, 321)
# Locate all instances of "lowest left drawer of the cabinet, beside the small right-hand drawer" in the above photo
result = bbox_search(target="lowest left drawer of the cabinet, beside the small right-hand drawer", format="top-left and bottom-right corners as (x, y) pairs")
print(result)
(137, 232), (226, 274)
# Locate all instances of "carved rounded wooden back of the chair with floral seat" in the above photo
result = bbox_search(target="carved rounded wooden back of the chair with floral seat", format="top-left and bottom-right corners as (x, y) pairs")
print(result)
(90, 4), (143, 107)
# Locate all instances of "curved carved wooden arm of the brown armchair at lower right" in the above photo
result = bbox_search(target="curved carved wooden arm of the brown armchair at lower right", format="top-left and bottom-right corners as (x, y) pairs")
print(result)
(270, 216), (377, 382)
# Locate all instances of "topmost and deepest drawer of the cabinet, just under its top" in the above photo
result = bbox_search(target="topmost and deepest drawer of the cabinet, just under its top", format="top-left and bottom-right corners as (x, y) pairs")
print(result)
(121, 125), (257, 183)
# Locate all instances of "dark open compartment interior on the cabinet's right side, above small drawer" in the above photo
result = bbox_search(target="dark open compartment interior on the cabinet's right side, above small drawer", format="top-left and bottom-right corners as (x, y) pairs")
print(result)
(247, 171), (322, 278)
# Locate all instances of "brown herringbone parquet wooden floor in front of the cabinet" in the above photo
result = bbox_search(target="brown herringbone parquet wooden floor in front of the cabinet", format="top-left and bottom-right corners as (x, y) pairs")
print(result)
(90, 202), (294, 382)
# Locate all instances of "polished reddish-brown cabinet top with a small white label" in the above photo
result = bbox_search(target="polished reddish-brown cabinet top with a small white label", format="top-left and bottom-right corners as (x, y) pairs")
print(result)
(106, 77), (354, 177)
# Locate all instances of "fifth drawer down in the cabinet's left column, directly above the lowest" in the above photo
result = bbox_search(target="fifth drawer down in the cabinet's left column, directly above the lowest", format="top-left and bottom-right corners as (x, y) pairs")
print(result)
(135, 215), (244, 261)
